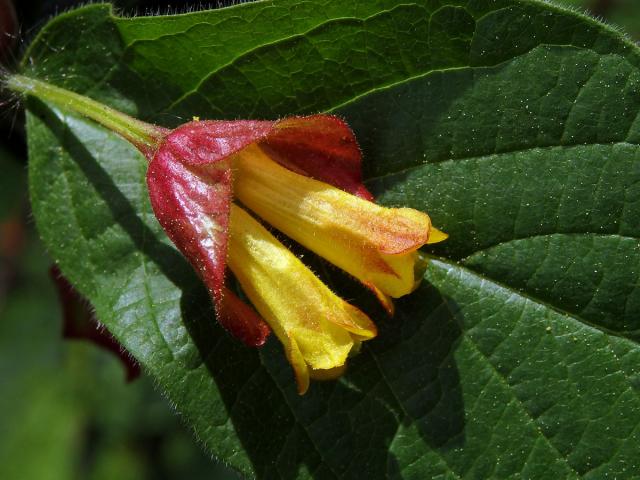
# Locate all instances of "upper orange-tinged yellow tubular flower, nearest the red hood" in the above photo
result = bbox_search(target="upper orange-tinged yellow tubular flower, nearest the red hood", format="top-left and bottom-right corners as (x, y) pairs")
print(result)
(233, 144), (447, 306)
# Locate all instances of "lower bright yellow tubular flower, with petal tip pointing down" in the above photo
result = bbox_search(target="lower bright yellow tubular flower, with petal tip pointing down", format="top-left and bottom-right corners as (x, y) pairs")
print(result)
(228, 205), (377, 394)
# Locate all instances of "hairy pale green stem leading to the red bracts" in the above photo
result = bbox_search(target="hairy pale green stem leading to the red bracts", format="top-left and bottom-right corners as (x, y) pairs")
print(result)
(5, 75), (168, 154)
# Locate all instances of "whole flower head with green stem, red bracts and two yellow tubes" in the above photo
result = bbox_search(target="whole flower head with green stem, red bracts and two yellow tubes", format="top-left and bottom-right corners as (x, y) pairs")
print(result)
(6, 75), (446, 394)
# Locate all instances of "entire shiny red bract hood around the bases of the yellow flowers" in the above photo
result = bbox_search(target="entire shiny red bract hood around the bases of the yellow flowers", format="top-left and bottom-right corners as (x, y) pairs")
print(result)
(146, 115), (373, 346)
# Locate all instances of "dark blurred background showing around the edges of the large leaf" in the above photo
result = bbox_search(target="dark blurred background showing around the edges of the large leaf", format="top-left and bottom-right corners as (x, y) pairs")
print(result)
(0, 0), (640, 480)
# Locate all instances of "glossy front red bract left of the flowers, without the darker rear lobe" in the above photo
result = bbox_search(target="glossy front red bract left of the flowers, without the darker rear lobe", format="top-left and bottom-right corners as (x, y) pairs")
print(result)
(147, 121), (272, 347)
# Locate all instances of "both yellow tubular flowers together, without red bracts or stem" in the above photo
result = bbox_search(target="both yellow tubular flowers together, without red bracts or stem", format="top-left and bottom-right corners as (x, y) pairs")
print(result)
(228, 145), (446, 394)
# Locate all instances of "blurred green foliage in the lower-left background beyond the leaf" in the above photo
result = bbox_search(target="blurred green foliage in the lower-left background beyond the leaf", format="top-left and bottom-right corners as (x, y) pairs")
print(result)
(0, 152), (237, 480)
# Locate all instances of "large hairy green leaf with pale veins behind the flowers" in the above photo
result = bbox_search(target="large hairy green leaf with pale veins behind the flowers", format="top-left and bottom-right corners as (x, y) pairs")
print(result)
(20, 0), (640, 479)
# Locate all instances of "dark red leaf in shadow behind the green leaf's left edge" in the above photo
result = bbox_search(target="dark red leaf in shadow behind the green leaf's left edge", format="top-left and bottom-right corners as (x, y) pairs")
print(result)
(49, 265), (140, 382)
